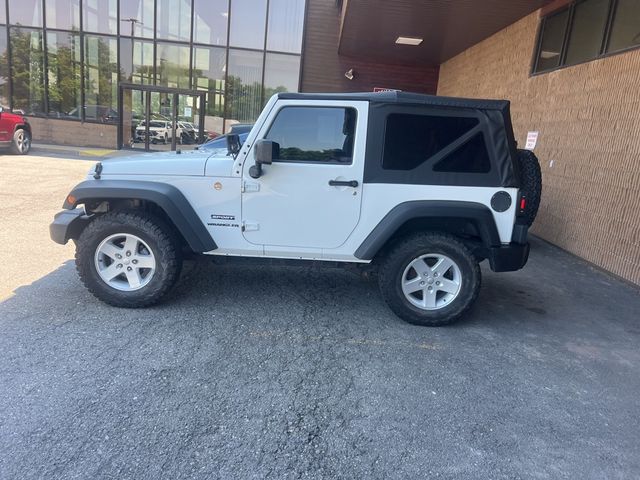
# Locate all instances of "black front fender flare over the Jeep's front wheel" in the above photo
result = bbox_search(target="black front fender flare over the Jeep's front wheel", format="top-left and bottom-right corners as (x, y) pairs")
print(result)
(63, 180), (218, 253)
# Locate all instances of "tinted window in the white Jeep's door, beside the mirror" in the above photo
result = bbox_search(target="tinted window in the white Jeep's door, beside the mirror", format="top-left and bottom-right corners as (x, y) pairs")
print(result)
(265, 107), (357, 164)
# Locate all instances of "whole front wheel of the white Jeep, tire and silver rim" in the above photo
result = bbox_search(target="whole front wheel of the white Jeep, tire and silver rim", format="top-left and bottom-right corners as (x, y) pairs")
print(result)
(76, 212), (182, 308)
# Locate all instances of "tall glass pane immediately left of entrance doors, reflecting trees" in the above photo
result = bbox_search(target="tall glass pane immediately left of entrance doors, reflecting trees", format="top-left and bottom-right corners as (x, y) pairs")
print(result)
(84, 35), (118, 123)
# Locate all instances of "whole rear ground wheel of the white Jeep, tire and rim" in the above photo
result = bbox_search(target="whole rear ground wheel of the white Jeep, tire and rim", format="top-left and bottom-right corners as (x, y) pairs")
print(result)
(378, 232), (481, 327)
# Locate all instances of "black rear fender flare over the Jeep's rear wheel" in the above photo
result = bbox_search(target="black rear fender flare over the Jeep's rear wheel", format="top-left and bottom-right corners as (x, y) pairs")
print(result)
(354, 200), (500, 260)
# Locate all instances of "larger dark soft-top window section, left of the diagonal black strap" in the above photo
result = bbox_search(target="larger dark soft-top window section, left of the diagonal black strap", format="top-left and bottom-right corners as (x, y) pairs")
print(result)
(382, 113), (479, 170)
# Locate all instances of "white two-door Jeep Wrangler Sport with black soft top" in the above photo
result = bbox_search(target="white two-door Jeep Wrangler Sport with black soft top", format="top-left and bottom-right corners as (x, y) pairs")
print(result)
(51, 92), (541, 326)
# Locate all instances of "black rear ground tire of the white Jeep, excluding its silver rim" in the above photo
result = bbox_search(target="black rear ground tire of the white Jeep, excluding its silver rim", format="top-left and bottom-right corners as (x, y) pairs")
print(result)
(378, 232), (481, 327)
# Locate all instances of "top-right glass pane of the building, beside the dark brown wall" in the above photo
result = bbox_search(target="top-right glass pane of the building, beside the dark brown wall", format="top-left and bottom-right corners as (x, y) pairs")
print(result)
(267, 0), (305, 53)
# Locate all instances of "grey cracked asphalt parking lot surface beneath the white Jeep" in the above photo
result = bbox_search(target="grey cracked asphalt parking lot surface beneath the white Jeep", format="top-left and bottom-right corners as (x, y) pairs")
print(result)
(0, 157), (640, 479)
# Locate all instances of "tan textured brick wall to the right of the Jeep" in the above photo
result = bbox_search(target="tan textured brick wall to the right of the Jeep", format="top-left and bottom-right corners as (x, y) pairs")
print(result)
(438, 13), (640, 284)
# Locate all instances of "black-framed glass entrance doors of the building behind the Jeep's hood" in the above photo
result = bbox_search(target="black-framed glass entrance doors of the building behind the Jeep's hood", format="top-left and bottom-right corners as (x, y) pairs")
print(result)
(118, 84), (207, 151)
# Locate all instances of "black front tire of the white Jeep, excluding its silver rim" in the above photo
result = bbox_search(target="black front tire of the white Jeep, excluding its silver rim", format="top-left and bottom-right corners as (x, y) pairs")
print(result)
(76, 211), (182, 308)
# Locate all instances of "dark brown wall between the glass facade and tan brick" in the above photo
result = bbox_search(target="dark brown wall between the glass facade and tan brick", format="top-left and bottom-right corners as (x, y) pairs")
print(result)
(300, 0), (438, 94)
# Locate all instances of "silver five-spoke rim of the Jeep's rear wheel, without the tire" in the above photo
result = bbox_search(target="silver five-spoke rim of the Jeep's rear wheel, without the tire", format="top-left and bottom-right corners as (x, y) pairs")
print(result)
(402, 253), (462, 310)
